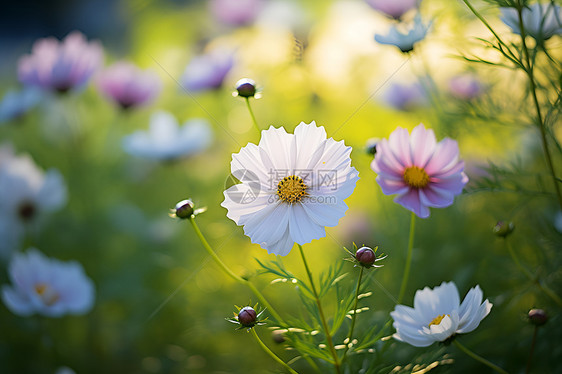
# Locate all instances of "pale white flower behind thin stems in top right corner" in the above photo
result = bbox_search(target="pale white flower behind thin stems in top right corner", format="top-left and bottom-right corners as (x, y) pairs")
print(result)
(501, 3), (562, 41)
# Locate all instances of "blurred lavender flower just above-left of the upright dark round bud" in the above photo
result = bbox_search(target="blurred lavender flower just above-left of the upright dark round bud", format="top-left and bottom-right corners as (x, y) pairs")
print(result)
(181, 50), (234, 92)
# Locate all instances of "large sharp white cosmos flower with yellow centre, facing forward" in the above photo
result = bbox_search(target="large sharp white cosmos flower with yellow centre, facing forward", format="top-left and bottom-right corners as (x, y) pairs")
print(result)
(221, 122), (359, 256)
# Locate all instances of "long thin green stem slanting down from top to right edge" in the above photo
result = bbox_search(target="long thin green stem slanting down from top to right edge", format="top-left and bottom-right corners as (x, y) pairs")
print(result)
(516, 1), (562, 209)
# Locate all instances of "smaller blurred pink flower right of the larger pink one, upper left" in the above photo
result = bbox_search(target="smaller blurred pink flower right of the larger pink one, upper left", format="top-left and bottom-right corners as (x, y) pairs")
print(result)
(97, 61), (162, 109)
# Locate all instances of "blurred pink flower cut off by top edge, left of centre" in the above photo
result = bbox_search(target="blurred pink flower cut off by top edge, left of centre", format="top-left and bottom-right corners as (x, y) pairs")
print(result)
(209, 0), (263, 26)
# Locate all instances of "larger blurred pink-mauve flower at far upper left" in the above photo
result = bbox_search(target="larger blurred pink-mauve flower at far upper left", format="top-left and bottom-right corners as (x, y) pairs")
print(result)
(18, 31), (103, 92)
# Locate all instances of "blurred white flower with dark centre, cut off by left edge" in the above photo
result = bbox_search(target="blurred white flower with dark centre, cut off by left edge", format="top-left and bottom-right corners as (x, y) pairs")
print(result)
(0, 145), (67, 258)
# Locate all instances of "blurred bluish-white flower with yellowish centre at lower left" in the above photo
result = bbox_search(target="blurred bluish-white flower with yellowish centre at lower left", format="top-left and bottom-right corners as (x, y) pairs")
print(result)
(2, 248), (95, 317)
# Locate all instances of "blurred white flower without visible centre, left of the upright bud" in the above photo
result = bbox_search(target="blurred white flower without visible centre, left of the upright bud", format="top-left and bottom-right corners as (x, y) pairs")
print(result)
(123, 111), (213, 161)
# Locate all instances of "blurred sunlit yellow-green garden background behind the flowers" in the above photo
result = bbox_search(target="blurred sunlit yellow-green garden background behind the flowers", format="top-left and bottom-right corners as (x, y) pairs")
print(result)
(0, 0), (562, 374)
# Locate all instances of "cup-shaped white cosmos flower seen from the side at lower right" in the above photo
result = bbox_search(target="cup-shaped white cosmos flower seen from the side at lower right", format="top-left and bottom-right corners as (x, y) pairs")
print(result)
(390, 282), (492, 347)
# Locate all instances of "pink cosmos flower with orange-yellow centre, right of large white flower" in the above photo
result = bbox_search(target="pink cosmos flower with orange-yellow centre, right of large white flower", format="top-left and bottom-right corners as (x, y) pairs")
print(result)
(371, 124), (468, 218)
